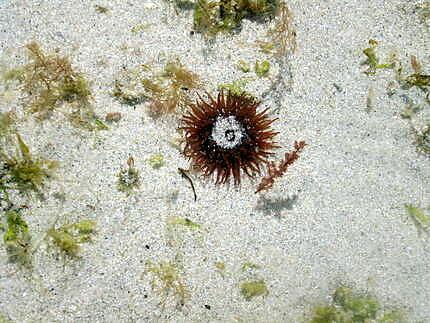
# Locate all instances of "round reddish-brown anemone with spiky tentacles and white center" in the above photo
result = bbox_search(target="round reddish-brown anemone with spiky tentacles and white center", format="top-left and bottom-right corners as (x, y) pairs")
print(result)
(181, 91), (278, 185)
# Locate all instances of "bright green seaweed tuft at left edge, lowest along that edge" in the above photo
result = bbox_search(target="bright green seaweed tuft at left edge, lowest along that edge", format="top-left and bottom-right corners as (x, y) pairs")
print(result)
(2, 210), (32, 268)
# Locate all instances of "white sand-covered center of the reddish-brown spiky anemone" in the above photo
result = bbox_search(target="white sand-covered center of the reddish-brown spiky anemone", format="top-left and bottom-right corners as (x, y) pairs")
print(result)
(211, 116), (245, 149)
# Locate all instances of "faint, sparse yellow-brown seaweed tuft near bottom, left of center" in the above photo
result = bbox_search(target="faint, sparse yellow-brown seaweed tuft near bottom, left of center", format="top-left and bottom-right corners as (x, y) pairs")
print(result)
(143, 261), (189, 307)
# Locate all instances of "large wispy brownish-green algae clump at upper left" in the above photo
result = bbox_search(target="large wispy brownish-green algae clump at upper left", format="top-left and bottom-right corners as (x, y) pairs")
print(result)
(3, 42), (101, 130)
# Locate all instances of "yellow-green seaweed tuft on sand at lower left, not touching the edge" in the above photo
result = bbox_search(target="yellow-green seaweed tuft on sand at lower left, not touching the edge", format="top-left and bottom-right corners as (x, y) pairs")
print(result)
(46, 220), (96, 258)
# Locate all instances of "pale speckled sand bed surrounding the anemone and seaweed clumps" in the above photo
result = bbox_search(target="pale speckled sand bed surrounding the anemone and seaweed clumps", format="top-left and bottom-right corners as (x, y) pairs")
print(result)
(0, 0), (430, 322)
